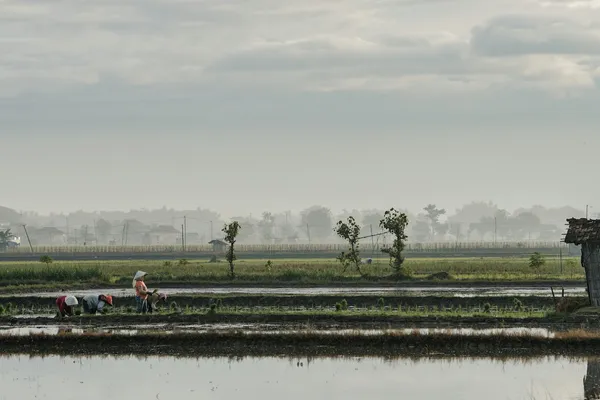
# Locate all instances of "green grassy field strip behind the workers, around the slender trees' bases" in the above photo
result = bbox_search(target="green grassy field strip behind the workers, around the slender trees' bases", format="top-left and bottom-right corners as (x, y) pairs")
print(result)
(0, 258), (584, 292)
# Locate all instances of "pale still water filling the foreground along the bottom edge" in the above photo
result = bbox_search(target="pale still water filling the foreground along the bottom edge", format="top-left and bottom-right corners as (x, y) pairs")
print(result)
(0, 350), (600, 400)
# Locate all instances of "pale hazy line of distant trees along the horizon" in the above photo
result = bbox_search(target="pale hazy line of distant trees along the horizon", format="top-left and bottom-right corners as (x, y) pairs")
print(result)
(0, 202), (585, 245)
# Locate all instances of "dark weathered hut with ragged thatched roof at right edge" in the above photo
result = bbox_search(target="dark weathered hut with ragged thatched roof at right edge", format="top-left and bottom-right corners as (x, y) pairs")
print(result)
(564, 218), (600, 307)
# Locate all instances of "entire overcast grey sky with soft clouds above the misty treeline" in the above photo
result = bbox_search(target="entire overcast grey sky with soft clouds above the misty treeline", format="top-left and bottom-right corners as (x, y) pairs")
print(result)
(0, 0), (600, 216)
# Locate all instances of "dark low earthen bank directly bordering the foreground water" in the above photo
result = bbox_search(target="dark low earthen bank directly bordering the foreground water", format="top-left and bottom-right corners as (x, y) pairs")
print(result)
(0, 332), (600, 358)
